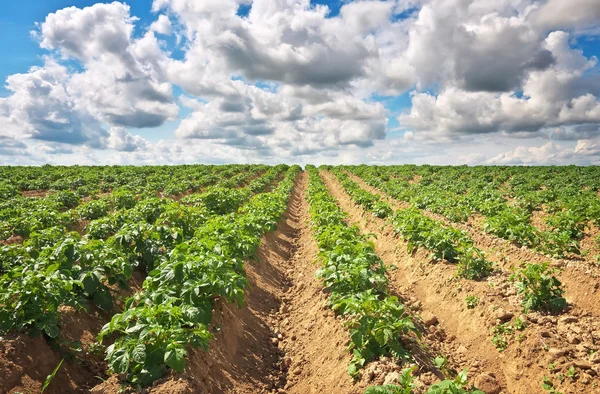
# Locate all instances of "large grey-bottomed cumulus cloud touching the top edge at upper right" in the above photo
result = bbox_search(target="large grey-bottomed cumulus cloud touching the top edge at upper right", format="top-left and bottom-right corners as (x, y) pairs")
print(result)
(404, 0), (554, 92)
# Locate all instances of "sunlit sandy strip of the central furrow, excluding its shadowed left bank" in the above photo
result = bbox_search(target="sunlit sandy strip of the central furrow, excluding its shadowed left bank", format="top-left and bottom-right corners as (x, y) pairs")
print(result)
(279, 172), (364, 394)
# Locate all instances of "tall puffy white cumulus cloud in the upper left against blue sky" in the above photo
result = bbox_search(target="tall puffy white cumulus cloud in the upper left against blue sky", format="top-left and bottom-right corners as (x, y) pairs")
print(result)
(34, 2), (178, 127)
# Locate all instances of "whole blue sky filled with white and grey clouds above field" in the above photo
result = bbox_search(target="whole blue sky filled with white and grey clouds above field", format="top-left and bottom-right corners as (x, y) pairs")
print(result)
(0, 0), (600, 165)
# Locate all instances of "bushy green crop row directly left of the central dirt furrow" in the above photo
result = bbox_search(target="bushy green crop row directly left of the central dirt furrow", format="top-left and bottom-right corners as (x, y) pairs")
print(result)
(99, 166), (300, 385)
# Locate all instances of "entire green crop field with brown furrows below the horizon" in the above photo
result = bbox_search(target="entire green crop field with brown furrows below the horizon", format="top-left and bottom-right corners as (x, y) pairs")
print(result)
(0, 165), (600, 394)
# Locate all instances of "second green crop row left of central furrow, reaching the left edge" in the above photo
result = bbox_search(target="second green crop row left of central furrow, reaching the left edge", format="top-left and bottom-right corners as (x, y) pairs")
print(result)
(0, 167), (284, 344)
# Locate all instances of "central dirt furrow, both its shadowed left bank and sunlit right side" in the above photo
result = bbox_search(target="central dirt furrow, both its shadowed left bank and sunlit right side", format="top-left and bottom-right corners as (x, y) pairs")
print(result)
(98, 173), (366, 394)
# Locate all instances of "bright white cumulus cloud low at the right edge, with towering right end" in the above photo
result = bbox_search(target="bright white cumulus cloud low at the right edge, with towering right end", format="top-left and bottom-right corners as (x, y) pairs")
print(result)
(399, 32), (600, 139)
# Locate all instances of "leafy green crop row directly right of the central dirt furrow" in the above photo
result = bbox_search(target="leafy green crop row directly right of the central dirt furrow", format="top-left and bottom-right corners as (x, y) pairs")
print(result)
(307, 166), (482, 394)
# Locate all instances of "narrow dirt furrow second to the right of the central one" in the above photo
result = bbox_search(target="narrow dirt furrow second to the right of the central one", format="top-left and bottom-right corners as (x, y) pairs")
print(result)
(348, 173), (600, 317)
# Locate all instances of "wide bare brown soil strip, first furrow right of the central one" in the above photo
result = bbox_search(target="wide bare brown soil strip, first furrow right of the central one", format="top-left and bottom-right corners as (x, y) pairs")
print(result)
(323, 172), (600, 394)
